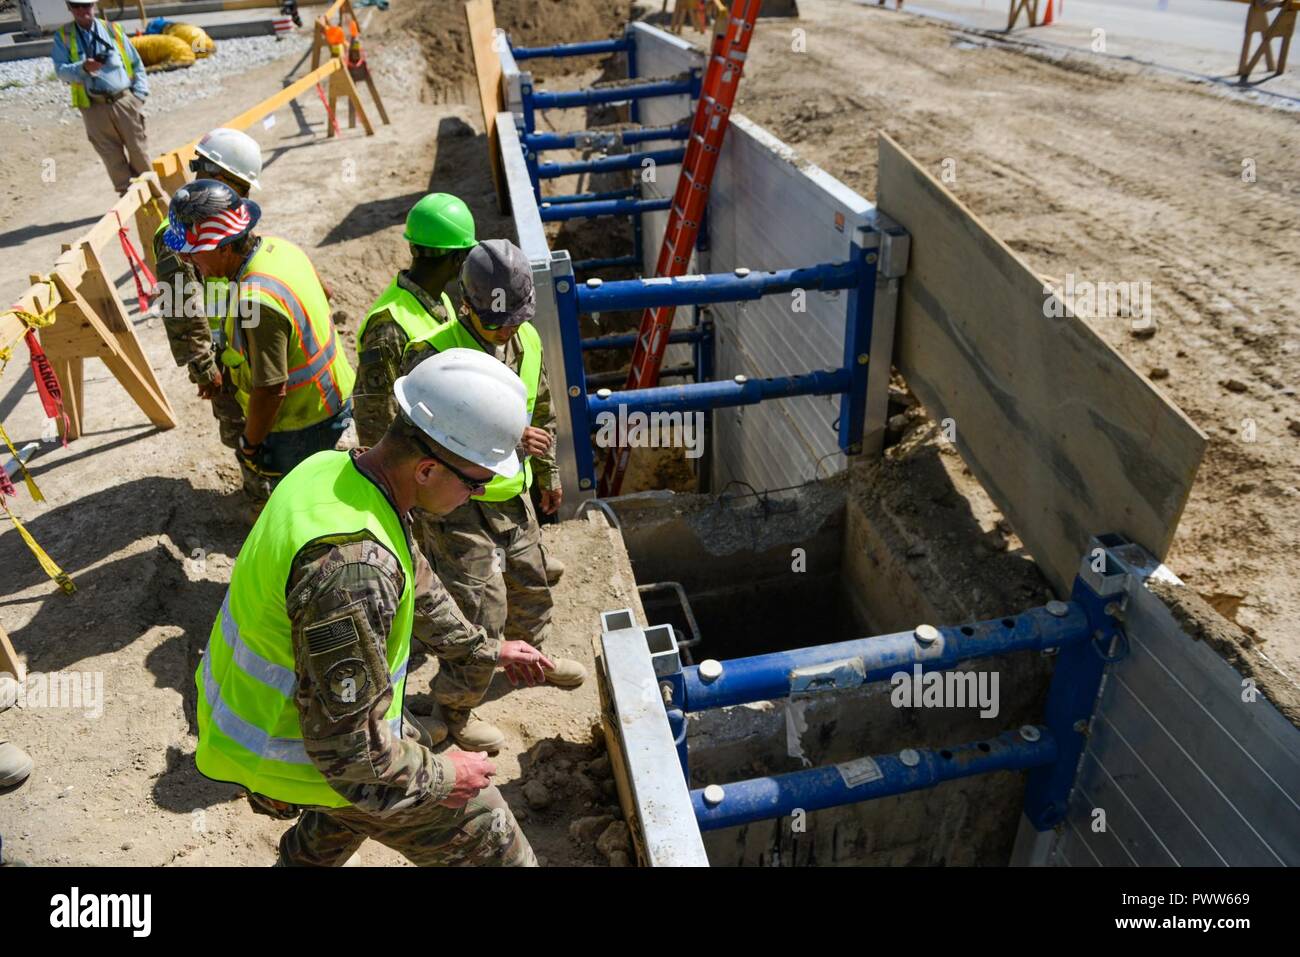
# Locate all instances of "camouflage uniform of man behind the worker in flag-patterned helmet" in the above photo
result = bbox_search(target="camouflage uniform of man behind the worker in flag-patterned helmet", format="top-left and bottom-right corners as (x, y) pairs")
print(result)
(153, 230), (245, 449)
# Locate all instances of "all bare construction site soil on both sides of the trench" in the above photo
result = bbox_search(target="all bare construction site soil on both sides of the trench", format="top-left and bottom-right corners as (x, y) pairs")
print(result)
(0, 0), (1300, 865)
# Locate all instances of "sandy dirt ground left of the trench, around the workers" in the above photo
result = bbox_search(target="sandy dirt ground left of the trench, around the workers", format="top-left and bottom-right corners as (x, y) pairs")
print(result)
(0, 3), (637, 866)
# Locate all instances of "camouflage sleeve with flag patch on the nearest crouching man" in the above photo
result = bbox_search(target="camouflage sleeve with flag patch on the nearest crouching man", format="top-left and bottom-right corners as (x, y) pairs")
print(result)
(286, 533), (456, 815)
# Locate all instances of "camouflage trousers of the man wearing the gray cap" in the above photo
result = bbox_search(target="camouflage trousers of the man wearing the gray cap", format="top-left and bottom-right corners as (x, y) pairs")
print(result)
(416, 495), (551, 709)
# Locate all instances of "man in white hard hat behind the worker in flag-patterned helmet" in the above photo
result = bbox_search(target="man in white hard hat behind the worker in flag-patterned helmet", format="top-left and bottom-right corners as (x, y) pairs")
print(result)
(153, 126), (261, 468)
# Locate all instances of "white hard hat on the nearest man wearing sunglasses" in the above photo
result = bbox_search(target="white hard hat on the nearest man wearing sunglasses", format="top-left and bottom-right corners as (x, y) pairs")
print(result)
(393, 348), (528, 479)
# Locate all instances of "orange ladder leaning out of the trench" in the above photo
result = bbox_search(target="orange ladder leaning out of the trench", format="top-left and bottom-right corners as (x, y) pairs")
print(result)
(599, 0), (762, 497)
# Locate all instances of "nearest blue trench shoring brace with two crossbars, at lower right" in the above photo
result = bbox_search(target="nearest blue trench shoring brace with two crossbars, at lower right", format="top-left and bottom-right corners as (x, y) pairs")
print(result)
(659, 536), (1128, 831)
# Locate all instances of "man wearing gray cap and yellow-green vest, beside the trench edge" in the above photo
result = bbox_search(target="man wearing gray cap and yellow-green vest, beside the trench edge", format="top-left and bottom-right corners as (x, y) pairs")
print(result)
(403, 239), (586, 752)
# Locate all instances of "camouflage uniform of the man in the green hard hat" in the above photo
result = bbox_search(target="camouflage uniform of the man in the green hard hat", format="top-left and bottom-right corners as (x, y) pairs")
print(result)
(352, 269), (459, 449)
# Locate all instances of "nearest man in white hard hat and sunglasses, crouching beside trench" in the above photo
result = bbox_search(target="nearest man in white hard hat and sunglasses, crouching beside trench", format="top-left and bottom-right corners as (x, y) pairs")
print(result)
(195, 350), (550, 866)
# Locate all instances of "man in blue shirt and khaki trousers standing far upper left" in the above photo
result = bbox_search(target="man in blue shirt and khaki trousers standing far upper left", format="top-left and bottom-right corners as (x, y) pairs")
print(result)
(49, 3), (150, 195)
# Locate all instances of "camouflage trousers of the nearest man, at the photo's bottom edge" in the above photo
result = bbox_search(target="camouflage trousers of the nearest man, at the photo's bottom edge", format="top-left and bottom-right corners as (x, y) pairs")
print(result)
(276, 787), (537, 867)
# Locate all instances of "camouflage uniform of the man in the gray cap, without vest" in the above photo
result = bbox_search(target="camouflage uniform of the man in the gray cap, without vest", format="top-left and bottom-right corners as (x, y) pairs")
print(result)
(402, 316), (560, 709)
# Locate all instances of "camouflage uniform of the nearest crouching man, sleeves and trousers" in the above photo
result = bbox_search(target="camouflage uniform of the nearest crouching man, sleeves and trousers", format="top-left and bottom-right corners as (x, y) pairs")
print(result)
(251, 452), (537, 866)
